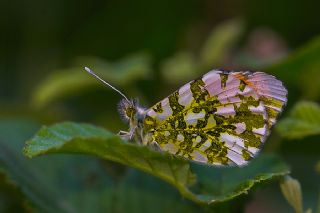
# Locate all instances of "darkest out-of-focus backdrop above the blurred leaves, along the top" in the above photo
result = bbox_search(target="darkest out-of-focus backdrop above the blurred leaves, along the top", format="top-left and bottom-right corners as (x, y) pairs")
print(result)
(0, 0), (320, 102)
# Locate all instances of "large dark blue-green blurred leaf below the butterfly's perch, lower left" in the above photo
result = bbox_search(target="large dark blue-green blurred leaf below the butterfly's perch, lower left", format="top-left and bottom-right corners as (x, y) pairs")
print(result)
(0, 119), (199, 213)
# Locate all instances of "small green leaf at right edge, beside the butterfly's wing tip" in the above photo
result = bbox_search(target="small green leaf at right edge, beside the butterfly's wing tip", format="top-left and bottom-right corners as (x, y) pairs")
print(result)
(276, 101), (320, 139)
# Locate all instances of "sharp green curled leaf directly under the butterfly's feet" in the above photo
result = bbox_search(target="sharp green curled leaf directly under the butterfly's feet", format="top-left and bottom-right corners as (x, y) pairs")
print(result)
(24, 122), (195, 191)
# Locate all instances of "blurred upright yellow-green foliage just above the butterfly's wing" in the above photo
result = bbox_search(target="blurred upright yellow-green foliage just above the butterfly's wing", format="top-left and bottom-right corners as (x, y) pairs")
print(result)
(161, 19), (244, 83)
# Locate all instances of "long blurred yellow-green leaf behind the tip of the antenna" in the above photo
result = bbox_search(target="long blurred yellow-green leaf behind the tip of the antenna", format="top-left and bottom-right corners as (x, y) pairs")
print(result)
(31, 54), (151, 107)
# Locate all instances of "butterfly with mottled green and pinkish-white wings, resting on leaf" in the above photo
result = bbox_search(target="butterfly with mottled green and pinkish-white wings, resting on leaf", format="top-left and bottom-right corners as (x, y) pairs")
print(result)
(85, 67), (288, 166)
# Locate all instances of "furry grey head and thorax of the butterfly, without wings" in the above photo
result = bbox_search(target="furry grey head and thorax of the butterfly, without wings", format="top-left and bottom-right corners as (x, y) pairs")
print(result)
(118, 99), (146, 143)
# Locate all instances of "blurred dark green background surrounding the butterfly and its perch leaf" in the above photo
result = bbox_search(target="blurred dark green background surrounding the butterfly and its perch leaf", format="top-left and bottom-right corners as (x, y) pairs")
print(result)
(0, 0), (320, 212)
